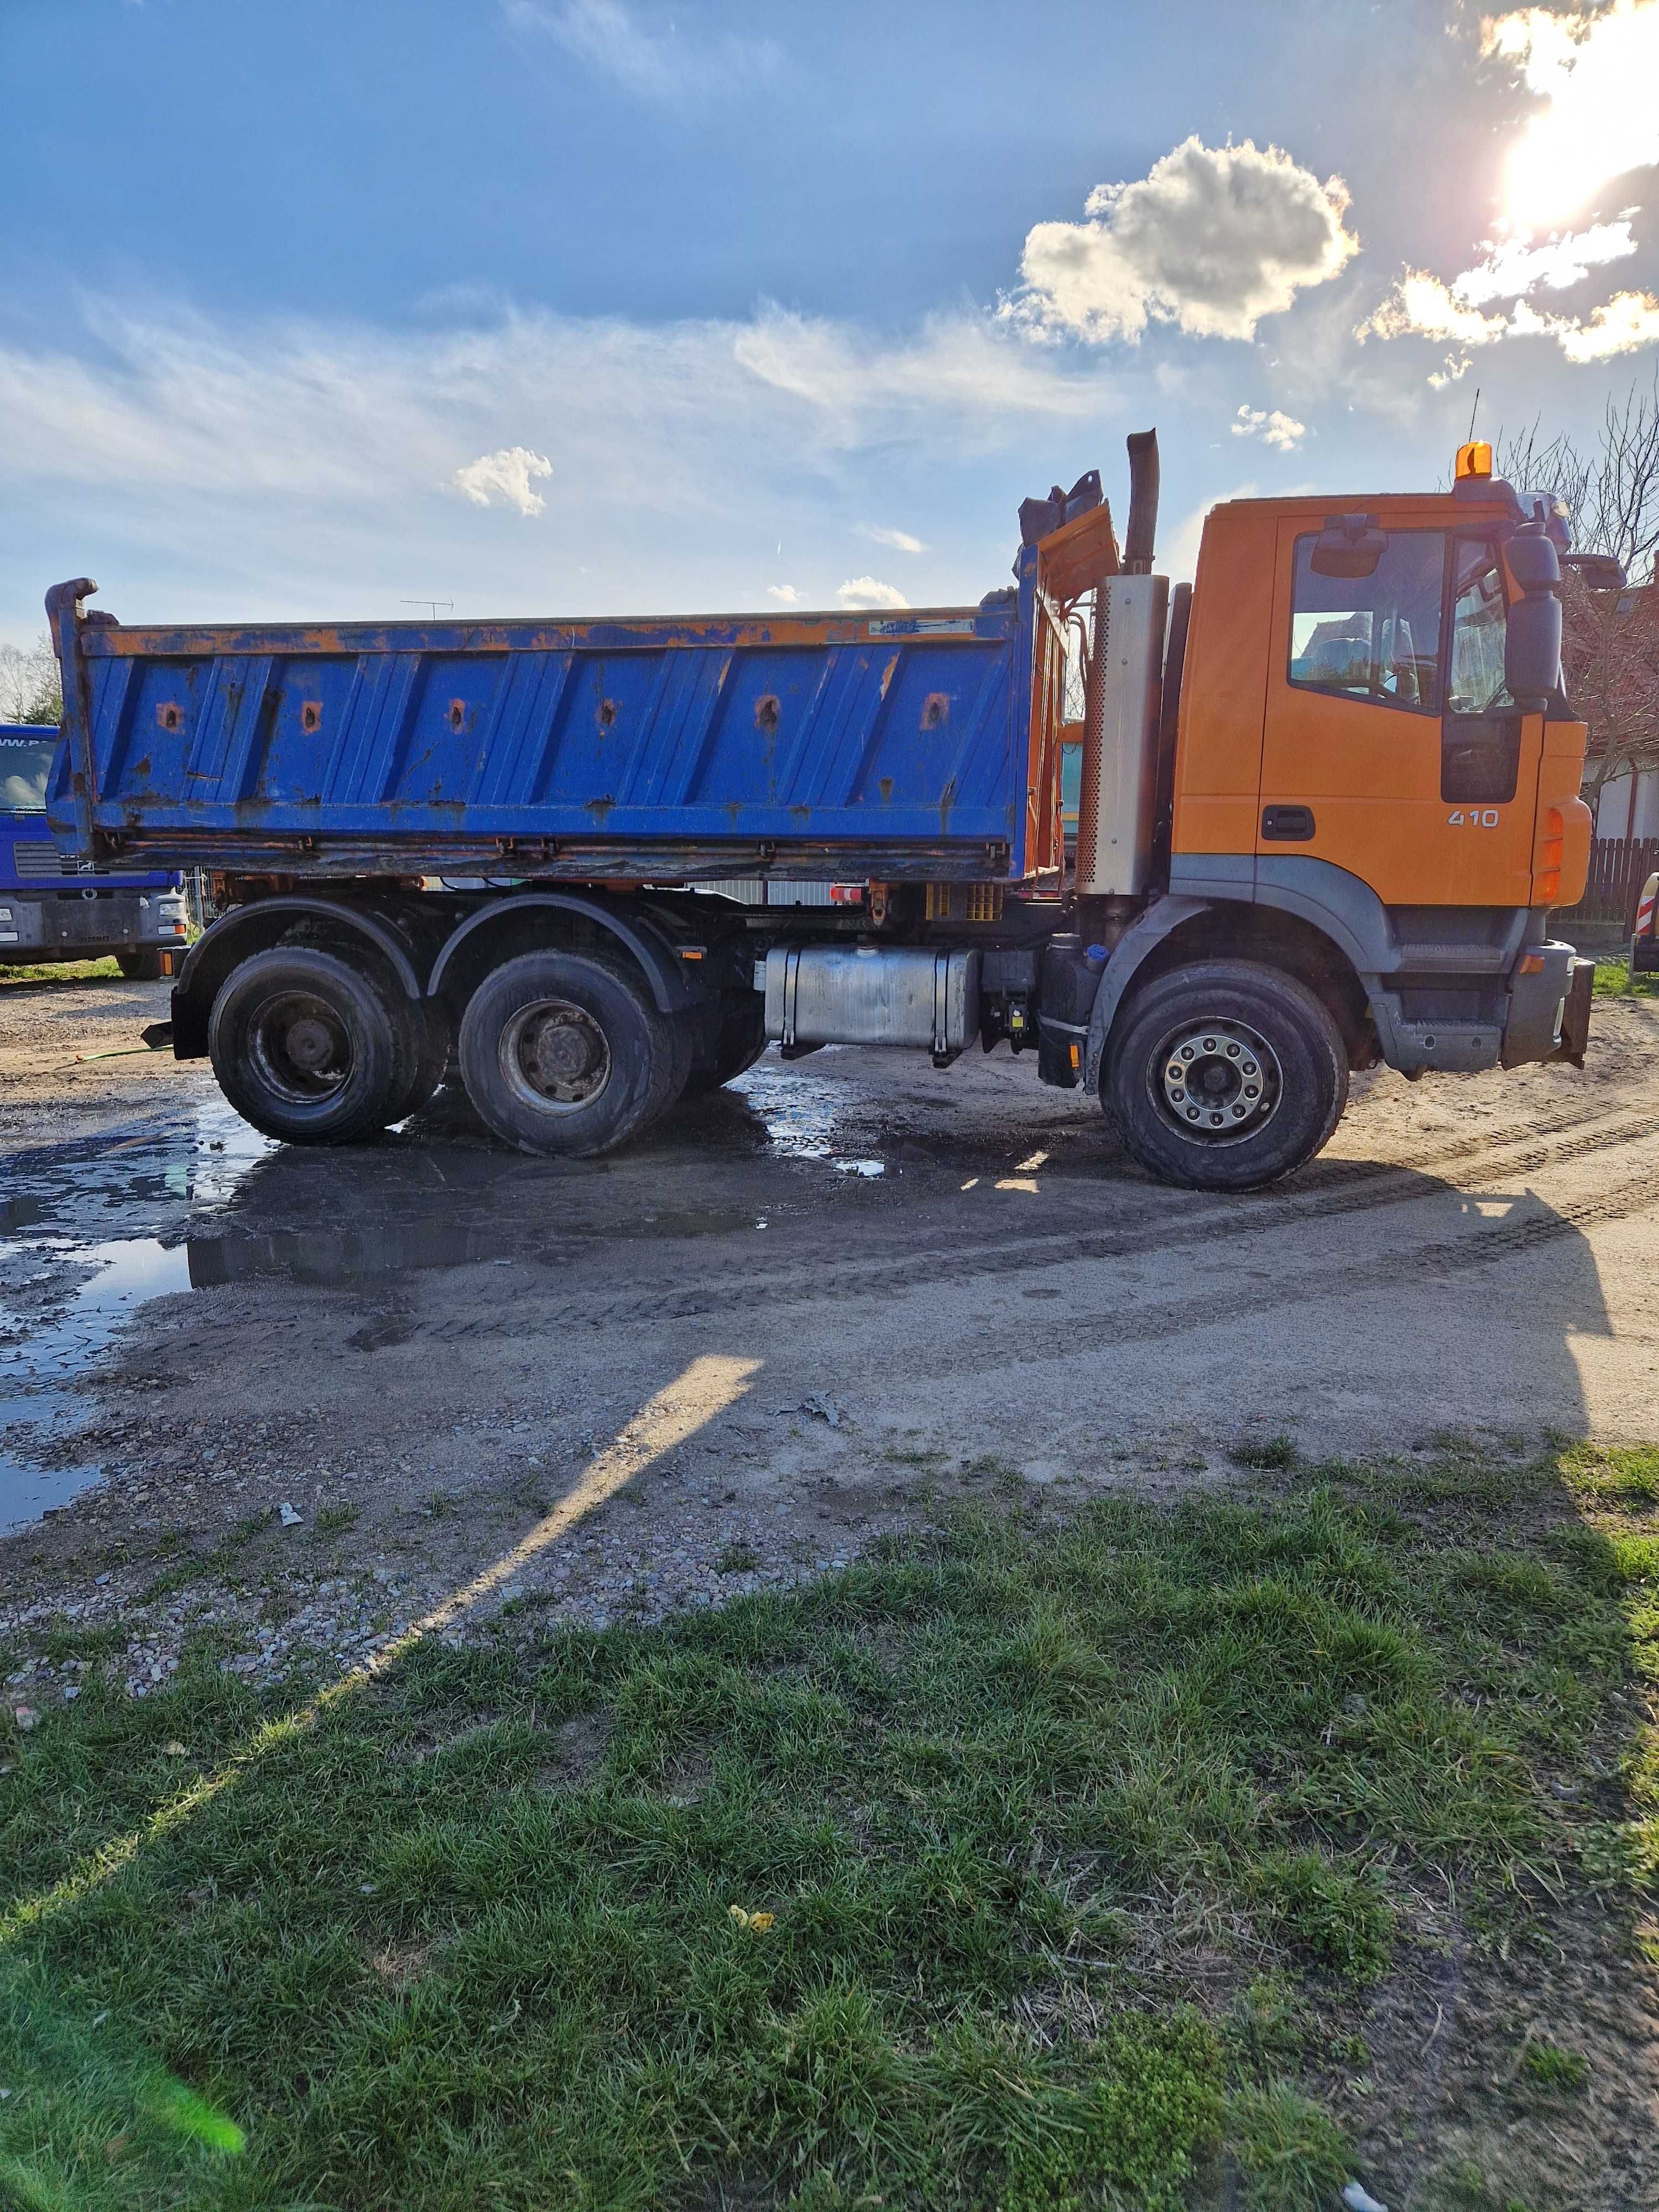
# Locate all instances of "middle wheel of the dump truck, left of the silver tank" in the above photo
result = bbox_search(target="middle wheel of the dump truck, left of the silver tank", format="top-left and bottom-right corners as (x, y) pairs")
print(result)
(460, 951), (690, 1159)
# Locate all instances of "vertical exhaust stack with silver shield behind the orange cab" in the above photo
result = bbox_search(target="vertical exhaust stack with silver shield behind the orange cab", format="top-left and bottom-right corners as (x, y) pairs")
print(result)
(1077, 429), (1170, 898)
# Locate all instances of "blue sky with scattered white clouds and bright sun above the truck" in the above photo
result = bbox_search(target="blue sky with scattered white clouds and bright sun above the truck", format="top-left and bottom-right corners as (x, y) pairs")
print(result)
(0, 0), (1659, 641)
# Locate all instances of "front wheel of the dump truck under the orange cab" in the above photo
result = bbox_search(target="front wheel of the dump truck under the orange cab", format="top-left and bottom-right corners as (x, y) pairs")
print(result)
(1102, 960), (1347, 1190)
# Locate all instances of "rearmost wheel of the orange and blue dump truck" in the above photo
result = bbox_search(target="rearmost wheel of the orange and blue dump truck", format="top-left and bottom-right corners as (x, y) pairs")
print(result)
(208, 945), (411, 1144)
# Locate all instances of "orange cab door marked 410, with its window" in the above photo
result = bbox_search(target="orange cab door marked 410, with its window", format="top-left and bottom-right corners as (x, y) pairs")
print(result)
(1256, 511), (1542, 909)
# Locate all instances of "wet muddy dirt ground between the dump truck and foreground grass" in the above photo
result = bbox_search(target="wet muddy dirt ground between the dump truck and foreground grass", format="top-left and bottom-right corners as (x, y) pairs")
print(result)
(0, 982), (1659, 1677)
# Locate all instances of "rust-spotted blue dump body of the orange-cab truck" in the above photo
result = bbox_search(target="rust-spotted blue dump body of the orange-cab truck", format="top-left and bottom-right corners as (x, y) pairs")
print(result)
(49, 535), (1084, 883)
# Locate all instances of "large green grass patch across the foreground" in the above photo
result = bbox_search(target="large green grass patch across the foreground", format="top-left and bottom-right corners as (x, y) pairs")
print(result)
(0, 1451), (1659, 2212)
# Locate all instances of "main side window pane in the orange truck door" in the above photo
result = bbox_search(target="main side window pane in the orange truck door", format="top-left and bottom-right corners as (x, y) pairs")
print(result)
(1290, 531), (1447, 714)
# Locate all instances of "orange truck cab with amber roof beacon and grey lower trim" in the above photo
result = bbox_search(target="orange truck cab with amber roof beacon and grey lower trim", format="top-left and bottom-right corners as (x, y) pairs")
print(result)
(1077, 447), (1593, 1186)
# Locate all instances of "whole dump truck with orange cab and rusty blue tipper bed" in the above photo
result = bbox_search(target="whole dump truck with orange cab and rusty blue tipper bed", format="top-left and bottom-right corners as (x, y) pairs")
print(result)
(46, 431), (1593, 1190)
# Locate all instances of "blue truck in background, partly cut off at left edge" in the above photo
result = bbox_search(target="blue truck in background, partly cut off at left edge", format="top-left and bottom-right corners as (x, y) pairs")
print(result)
(0, 723), (190, 982)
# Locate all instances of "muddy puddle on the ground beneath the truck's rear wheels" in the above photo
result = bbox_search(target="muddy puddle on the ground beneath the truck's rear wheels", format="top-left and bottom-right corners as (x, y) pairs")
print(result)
(0, 1064), (887, 1533)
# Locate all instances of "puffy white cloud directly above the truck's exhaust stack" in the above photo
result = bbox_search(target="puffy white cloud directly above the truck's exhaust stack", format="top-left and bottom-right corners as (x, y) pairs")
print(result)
(1002, 137), (1358, 343)
